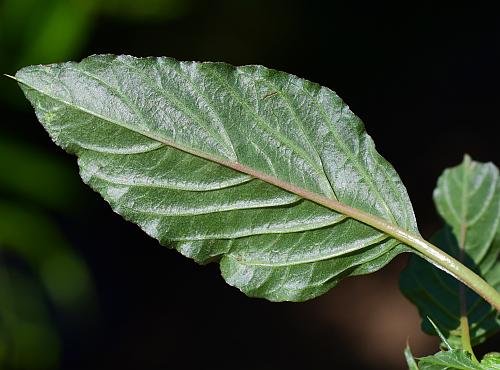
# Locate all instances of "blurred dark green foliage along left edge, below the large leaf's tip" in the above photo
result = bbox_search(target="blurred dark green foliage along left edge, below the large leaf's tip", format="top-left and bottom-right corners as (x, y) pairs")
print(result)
(0, 134), (96, 369)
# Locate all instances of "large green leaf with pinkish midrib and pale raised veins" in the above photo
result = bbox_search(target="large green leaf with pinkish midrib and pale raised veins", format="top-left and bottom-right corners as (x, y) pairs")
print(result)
(16, 55), (418, 301)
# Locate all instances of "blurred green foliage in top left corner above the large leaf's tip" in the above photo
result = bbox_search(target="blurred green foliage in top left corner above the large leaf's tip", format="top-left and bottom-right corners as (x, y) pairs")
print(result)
(0, 0), (191, 106)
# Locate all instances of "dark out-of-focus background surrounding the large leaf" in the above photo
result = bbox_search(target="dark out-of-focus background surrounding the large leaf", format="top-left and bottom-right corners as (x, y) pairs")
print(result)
(0, 0), (500, 370)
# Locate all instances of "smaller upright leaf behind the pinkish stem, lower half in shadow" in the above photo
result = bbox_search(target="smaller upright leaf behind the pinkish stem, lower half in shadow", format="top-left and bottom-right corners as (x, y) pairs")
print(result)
(400, 156), (500, 348)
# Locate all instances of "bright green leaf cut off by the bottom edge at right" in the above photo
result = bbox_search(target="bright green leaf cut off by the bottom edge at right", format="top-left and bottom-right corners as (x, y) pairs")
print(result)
(418, 349), (486, 370)
